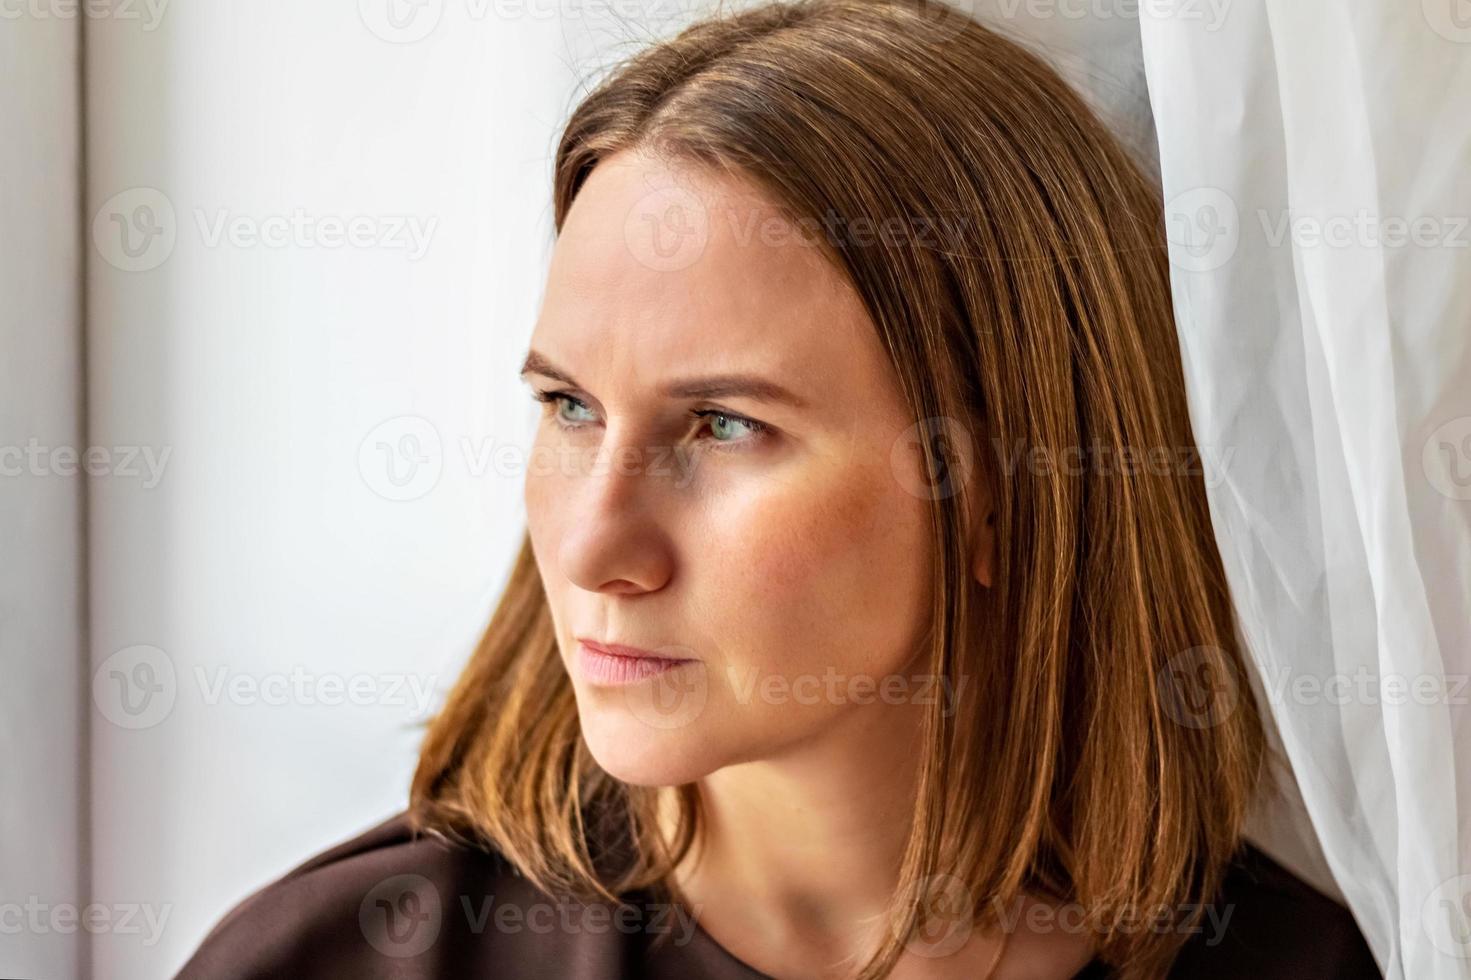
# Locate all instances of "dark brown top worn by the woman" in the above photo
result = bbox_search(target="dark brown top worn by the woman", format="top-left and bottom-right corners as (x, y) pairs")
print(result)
(175, 812), (1380, 980)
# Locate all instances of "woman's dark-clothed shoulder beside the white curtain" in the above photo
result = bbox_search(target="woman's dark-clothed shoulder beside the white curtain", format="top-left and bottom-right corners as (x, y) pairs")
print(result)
(1169, 840), (1381, 980)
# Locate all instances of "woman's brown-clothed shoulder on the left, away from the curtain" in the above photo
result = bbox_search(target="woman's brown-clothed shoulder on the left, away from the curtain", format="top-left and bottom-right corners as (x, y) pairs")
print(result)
(177, 812), (632, 980)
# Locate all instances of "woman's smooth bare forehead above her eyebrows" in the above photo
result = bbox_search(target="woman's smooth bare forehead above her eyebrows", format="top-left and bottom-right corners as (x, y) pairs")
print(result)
(531, 156), (887, 409)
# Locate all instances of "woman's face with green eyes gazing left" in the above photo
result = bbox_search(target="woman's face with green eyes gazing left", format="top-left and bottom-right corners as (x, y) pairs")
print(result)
(524, 153), (944, 786)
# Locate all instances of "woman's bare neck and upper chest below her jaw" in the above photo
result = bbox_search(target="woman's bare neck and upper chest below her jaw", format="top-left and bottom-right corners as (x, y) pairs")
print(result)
(660, 691), (1093, 980)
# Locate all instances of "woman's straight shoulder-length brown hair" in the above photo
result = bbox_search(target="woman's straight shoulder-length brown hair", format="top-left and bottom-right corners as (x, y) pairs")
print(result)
(410, 0), (1268, 979)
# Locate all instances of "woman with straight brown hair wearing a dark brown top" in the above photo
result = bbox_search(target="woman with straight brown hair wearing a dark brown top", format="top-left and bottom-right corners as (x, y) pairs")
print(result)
(172, 0), (1378, 980)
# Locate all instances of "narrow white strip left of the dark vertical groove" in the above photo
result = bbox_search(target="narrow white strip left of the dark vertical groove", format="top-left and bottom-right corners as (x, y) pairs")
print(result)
(0, 7), (85, 977)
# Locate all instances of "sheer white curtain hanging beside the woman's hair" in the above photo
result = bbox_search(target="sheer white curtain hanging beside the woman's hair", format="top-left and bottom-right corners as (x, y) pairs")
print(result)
(1140, 0), (1471, 980)
